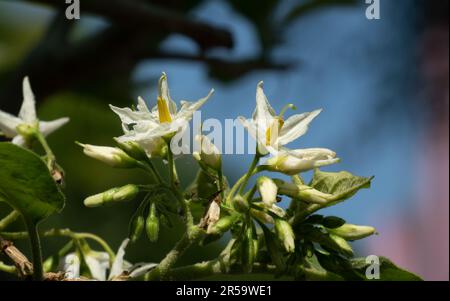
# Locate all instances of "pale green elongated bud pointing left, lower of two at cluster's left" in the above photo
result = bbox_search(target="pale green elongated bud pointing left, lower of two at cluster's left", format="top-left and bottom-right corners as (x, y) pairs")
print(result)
(84, 184), (139, 207)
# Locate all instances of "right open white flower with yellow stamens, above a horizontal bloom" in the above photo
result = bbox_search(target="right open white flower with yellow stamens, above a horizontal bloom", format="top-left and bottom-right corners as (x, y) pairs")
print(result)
(239, 82), (322, 154)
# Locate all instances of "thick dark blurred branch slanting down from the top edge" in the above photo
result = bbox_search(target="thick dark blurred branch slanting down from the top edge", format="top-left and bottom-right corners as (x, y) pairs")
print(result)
(29, 0), (233, 49)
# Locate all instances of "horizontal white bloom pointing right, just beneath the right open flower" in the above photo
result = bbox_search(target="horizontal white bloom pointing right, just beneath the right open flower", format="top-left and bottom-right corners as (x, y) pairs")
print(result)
(265, 148), (340, 175)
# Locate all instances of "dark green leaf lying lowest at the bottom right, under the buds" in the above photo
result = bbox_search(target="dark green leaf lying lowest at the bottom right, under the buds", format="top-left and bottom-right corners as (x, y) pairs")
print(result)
(350, 257), (422, 281)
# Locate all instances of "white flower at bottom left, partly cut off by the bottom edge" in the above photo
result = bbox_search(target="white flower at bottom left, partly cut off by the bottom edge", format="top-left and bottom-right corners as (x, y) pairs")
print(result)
(61, 238), (157, 281)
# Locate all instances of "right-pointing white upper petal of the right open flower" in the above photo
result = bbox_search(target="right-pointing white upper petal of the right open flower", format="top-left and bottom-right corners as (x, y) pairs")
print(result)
(278, 109), (322, 145)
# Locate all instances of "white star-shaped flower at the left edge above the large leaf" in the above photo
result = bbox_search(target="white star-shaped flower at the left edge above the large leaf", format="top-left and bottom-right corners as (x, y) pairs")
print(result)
(0, 77), (69, 145)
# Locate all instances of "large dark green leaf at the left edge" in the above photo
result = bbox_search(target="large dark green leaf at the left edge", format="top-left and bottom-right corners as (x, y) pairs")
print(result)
(0, 142), (64, 224)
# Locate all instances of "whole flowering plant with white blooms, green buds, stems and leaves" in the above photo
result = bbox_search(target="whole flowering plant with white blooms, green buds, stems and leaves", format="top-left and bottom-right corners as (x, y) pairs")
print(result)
(0, 73), (418, 280)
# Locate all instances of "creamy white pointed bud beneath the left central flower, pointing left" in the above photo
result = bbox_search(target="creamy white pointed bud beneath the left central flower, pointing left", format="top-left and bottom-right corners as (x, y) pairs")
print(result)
(77, 143), (137, 168)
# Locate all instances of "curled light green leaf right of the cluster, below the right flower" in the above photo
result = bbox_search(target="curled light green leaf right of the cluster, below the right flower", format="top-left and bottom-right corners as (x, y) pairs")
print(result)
(309, 169), (374, 203)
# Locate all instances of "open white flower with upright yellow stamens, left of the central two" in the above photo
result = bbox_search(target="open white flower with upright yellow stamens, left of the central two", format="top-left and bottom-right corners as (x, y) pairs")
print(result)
(110, 73), (214, 149)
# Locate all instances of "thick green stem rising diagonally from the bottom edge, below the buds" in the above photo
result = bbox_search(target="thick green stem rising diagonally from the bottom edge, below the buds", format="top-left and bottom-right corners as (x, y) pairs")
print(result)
(145, 226), (204, 281)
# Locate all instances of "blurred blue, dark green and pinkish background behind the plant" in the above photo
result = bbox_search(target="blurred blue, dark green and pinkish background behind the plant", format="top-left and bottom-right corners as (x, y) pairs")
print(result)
(0, 0), (449, 280)
